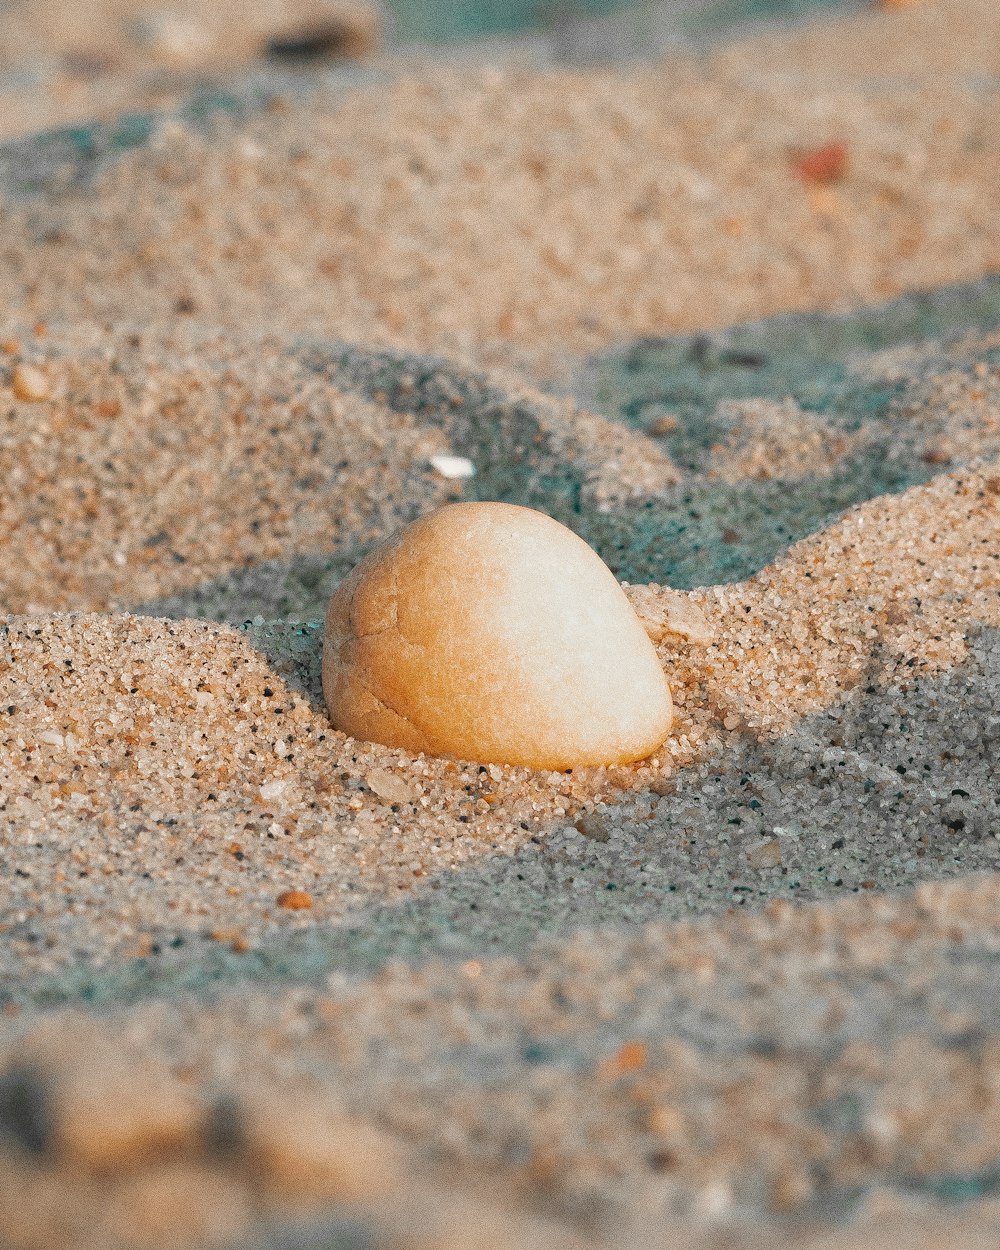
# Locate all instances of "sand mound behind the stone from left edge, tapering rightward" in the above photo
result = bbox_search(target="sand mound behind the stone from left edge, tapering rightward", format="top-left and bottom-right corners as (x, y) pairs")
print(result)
(0, 329), (679, 620)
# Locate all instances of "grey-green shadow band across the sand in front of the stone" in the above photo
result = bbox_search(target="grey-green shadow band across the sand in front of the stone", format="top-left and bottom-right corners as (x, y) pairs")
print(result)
(24, 629), (1000, 1004)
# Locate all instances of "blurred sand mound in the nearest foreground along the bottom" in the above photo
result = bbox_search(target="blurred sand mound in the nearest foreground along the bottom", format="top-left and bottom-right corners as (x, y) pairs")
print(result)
(0, 881), (1000, 1250)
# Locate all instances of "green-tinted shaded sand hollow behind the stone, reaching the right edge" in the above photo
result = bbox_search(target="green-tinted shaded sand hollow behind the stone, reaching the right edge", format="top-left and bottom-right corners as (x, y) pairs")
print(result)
(580, 279), (1000, 586)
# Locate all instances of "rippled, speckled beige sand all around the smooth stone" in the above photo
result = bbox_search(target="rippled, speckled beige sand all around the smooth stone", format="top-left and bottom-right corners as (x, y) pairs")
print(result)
(0, 0), (1000, 1250)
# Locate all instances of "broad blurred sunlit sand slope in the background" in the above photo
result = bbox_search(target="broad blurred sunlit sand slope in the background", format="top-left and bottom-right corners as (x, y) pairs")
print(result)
(0, 0), (1000, 375)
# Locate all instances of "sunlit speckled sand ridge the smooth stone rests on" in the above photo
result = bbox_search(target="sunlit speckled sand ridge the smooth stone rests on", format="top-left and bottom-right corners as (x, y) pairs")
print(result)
(0, 442), (1000, 978)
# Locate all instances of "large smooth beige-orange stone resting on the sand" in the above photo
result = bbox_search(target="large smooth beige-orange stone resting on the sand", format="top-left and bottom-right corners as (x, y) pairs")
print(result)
(323, 504), (673, 769)
